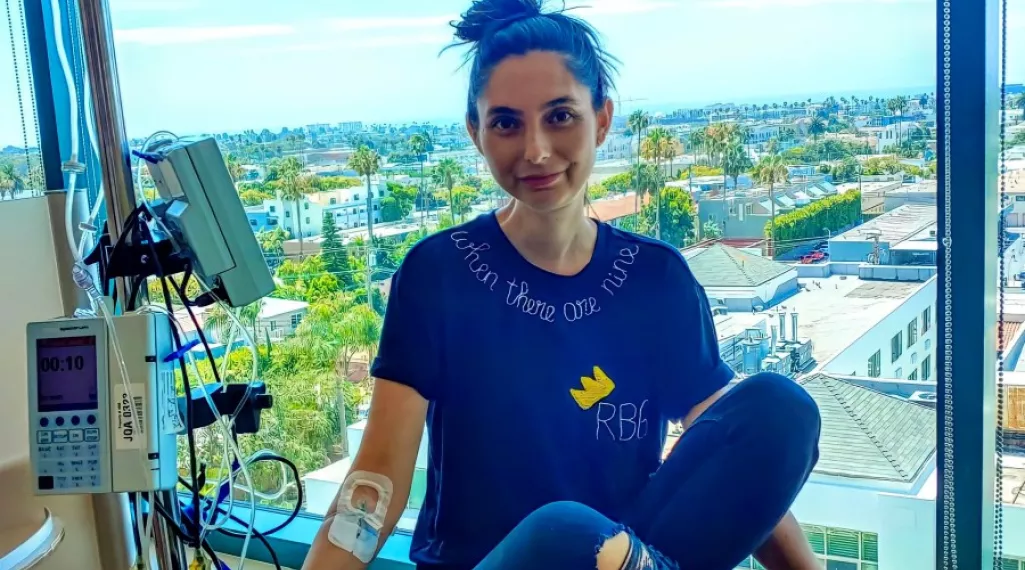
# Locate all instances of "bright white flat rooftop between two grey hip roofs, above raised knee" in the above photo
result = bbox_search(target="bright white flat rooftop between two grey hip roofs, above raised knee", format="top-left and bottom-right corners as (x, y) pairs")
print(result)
(781, 276), (923, 364)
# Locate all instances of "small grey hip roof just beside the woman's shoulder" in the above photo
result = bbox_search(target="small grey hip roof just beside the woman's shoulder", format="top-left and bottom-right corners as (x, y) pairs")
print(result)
(684, 243), (794, 287)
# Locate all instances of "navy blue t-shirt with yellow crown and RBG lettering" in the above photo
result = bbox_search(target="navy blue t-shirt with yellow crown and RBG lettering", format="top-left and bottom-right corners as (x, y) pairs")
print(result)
(371, 213), (733, 570)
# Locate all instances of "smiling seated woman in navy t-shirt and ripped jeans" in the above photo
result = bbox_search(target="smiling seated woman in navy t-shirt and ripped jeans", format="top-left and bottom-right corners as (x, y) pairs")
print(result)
(305, 0), (819, 570)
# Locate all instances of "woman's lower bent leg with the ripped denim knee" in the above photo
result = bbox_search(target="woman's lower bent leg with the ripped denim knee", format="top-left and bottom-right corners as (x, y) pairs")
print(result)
(475, 501), (672, 570)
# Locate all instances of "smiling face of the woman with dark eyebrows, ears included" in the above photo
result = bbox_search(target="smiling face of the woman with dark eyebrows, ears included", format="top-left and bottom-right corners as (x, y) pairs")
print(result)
(467, 51), (612, 212)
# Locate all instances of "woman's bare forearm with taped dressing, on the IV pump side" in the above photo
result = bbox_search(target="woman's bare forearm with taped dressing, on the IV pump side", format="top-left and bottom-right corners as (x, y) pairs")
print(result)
(302, 379), (427, 570)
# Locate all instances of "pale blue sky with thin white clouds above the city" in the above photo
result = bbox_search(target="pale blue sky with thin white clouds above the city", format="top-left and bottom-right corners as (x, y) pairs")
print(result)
(0, 0), (1025, 148)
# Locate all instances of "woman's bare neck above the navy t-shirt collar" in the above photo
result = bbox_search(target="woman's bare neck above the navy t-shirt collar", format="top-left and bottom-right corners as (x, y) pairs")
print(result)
(496, 200), (598, 275)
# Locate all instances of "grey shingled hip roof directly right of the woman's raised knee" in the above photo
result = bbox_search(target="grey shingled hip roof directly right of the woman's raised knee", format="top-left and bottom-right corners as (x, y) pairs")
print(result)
(801, 374), (936, 483)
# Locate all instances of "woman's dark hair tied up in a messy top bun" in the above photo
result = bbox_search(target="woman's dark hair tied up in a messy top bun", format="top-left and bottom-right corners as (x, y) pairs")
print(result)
(445, 0), (617, 125)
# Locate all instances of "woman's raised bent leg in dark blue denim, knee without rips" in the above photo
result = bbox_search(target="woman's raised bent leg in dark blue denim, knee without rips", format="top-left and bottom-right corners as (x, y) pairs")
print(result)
(623, 373), (820, 570)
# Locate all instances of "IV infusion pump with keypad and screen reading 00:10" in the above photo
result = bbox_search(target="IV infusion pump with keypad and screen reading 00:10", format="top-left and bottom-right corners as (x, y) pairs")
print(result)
(27, 313), (183, 495)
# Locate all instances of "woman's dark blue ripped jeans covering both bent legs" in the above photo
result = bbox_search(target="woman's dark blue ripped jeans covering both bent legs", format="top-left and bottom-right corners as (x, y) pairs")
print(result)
(476, 373), (820, 570)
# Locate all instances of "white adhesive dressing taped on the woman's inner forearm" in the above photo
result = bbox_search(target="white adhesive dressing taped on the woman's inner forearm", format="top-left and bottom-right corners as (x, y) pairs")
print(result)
(327, 471), (393, 564)
